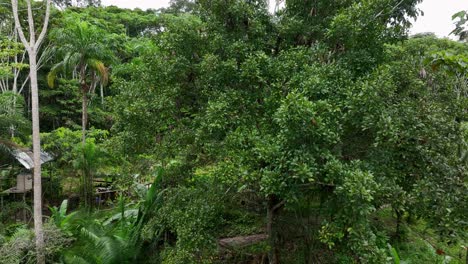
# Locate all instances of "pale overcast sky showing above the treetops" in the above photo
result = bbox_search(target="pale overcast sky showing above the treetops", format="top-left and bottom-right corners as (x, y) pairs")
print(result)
(102, 0), (468, 37)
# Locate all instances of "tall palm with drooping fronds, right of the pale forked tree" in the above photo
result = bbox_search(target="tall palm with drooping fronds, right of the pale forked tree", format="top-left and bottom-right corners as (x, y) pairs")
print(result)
(47, 21), (112, 144)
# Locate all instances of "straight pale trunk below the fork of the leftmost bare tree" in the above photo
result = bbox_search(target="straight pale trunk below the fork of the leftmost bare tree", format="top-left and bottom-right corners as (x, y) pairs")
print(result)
(29, 50), (45, 263)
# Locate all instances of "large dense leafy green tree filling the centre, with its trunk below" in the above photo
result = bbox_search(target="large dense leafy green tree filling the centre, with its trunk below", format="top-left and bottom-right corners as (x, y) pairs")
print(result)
(107, 0), (465, 262)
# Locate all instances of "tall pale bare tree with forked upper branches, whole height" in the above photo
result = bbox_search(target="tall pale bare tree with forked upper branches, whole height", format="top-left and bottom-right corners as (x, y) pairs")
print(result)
(11, 0), (51, 264)
